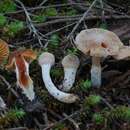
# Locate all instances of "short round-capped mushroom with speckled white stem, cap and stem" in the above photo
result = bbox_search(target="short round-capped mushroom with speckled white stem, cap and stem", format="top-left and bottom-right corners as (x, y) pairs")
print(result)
(59, 54), (79, 92)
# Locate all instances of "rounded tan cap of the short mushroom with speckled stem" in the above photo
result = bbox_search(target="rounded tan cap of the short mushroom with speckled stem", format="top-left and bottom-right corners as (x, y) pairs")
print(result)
(62, 54), (80, 68)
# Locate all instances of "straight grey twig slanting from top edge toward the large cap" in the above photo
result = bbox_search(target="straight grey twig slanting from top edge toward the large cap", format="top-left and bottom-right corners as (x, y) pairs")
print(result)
(67, 0), (97, 40)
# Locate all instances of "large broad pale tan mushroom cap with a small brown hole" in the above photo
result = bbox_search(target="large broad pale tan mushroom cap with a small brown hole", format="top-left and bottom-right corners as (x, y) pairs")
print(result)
(75, 28), (123, 57)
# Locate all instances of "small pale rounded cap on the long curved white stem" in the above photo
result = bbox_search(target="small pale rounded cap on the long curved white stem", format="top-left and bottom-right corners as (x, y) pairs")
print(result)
(38, 52), (55, 66)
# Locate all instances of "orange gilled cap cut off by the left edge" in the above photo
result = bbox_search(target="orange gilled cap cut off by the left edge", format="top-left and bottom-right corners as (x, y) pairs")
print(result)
(0, 39), (9, 64)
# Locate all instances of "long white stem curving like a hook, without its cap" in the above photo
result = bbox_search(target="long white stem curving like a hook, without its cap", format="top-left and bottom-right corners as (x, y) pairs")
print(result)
(42, 64), (78, 103)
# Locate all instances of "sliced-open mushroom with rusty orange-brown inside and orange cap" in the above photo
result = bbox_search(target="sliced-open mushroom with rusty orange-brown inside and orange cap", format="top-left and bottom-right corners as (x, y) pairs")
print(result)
(6, 49), (37, 101)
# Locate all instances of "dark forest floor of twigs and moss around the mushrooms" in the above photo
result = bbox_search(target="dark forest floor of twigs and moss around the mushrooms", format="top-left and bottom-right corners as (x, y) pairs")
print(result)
(0, 0), (130, 130)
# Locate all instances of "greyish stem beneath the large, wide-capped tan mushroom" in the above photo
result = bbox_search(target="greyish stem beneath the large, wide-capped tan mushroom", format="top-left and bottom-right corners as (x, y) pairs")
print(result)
(91, 56), (101, 87)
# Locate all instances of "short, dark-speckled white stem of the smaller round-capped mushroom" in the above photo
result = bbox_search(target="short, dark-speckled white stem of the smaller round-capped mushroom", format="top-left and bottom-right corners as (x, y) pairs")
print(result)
(59, 68), (77, 92)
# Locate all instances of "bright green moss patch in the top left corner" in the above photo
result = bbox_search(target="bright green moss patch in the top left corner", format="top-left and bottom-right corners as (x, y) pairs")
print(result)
(0, 0), (16, 13)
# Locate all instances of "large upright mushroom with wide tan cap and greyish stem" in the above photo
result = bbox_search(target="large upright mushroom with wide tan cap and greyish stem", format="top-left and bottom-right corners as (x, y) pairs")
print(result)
(75, 28), (123, 87)
